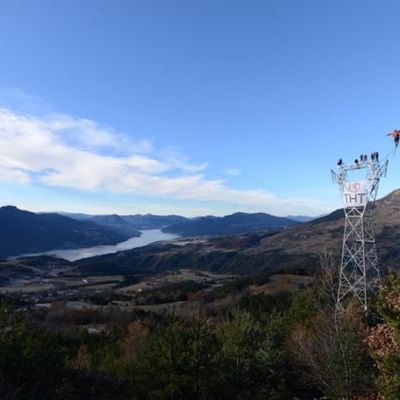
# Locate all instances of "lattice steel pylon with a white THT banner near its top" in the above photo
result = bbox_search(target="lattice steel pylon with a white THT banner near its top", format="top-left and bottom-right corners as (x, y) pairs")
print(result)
(332, 153), (388, 311)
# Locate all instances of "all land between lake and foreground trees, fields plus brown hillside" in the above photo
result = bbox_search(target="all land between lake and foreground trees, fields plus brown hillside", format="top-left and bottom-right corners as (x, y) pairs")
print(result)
(0, 190), (400, 322)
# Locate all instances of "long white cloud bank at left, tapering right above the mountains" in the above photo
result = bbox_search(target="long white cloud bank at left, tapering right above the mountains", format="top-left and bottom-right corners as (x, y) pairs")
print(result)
(0, 109), (326, 214)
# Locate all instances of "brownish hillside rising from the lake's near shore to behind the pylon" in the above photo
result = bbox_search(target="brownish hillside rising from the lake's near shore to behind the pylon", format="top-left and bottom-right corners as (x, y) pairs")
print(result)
(77, 190), (400, 274)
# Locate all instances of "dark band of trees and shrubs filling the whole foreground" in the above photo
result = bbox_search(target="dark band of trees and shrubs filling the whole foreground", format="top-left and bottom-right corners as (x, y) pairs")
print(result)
(0, 269), (400, 400)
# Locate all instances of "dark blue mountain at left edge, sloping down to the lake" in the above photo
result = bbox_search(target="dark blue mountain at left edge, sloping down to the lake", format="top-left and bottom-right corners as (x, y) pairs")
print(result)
(0, 206), (129, 258)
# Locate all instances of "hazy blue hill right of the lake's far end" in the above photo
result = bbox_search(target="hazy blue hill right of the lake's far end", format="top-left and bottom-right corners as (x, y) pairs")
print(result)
(163, 212), (298, 236)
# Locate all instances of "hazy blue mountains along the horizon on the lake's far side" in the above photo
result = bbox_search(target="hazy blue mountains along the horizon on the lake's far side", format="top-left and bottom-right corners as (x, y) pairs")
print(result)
(0, 206), (304, 258)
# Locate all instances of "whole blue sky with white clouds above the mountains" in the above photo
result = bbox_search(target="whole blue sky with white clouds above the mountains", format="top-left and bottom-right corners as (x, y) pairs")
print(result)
(0, 0), (400, 215)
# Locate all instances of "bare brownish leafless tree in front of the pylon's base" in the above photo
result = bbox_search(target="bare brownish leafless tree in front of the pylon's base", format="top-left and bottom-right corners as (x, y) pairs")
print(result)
(289, 253), (373, 400)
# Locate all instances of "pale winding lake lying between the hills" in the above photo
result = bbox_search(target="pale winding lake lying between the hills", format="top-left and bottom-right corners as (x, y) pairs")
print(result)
(18, 229), (179, 261)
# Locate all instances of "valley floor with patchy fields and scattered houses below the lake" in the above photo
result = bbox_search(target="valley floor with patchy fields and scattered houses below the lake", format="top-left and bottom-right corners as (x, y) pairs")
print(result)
(0, 252), (311, 329)
